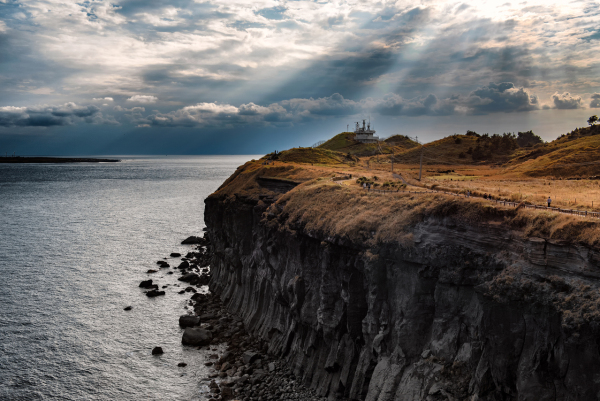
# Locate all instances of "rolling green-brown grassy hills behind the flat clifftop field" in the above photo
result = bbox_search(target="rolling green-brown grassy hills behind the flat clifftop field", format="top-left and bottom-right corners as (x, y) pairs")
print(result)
(314, 125), (600, 178)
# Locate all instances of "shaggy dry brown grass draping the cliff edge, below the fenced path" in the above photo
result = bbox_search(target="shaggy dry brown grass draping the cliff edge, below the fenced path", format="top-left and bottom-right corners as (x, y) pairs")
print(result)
(268, 179), (600, 246)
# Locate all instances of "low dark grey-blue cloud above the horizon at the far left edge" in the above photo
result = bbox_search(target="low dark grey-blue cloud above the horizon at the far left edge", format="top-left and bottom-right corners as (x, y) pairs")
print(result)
(0, 103), (118, 127)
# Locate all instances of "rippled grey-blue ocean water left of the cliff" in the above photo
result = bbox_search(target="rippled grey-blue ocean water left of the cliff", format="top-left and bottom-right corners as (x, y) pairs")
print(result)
(0, 156), (252, 400)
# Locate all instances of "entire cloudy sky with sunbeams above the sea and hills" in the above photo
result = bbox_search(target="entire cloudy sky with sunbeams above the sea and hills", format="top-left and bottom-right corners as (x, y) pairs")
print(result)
(0, 0), (600, 155)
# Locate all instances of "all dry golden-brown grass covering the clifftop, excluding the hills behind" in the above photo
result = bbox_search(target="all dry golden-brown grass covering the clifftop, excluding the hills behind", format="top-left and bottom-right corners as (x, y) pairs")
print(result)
(213, 157), (600, 246)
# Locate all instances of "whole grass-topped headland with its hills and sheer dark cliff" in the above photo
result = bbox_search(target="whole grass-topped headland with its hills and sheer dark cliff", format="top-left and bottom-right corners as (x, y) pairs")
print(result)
(197, 123), (600, 401)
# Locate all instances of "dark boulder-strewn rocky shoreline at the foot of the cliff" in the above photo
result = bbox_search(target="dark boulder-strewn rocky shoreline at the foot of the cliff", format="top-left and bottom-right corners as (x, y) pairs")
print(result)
(142, 236), (331, 401)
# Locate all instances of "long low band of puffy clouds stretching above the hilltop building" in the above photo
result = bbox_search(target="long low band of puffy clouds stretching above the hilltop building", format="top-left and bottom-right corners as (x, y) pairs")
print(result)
(126, 82), (540, 127)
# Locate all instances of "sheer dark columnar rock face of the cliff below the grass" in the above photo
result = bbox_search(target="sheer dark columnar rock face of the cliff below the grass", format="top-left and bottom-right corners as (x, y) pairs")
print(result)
(205, 183), (600, 401)
